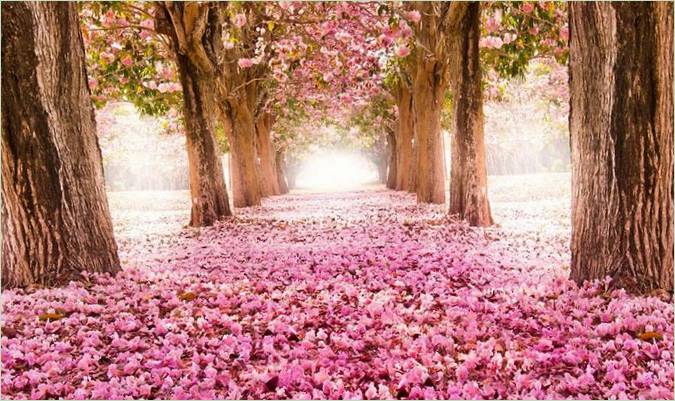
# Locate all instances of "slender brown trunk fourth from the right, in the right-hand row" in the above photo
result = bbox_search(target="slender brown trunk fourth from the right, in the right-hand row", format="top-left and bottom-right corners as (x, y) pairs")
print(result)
(394, 84), (414, 191)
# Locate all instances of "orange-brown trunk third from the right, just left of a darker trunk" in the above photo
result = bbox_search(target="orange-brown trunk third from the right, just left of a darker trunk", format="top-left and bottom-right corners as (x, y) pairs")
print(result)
(413, 64), (445, 203)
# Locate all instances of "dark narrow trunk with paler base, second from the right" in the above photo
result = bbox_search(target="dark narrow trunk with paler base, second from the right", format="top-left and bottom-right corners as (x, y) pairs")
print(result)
(450, 2), (493, 226)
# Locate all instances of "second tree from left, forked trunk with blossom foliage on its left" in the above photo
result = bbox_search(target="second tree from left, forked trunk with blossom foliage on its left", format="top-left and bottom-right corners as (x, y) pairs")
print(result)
(82, 2), (232, 226)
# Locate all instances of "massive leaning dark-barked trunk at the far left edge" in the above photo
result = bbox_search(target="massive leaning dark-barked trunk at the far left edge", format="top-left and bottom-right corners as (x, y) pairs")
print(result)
(1, 2), (120, 288)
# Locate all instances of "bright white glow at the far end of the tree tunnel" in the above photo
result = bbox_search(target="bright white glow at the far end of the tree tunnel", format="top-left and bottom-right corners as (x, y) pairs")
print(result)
(296, 150), (377, 191)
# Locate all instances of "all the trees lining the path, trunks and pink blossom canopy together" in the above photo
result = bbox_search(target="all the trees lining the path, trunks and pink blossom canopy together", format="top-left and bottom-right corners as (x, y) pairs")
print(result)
(2, 2), (673, 292)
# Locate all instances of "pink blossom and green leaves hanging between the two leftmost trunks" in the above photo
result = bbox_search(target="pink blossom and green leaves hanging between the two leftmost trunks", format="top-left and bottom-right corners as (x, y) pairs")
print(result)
(80, 2), (182, 115)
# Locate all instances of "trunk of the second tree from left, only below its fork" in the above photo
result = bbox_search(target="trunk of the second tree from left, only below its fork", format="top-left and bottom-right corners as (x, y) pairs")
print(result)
(177, 54), (232, 227)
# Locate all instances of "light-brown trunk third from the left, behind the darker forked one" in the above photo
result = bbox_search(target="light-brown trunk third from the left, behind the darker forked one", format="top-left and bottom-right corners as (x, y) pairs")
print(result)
(228, 104), (260, 207)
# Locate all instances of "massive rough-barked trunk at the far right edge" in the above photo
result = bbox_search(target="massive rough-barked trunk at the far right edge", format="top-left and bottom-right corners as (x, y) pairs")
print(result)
(569, 2), (673, 293)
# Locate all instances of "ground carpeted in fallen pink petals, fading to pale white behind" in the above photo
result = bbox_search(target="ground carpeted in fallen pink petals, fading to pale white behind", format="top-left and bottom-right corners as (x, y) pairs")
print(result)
(1, 175), (673, 399)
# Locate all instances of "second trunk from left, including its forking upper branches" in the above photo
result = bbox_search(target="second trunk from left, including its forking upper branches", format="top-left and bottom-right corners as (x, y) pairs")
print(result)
(156, 2), (232, 223)
